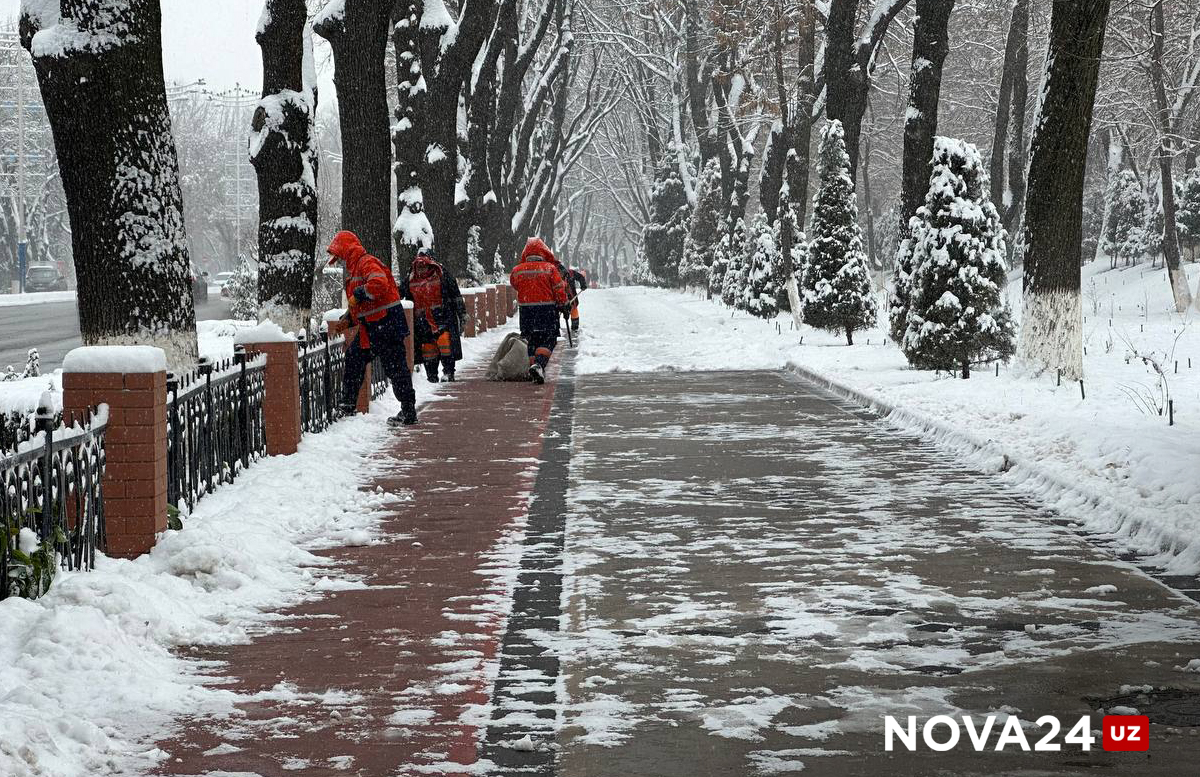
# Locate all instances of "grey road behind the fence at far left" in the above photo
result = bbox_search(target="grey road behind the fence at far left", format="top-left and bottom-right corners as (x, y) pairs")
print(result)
(0, 293), (229, 372)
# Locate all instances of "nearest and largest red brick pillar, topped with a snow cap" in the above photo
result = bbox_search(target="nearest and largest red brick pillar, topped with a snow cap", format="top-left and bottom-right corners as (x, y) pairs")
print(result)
(62, 347), (167, 559)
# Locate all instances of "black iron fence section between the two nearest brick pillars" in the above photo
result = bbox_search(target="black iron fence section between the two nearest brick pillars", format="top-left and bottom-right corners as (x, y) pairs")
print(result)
(167, 347), (266, 510)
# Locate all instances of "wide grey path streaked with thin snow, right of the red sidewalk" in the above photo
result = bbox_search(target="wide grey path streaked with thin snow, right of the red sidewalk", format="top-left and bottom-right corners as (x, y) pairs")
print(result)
(520, 373), (1200, 777)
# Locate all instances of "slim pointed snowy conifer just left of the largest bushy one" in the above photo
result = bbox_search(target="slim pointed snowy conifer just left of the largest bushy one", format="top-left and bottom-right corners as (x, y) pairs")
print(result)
(800, 120), (878, 344)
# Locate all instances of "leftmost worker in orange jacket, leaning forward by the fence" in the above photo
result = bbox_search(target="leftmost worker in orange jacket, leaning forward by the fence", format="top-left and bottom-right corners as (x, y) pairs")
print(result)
(328, 231), (416, 426)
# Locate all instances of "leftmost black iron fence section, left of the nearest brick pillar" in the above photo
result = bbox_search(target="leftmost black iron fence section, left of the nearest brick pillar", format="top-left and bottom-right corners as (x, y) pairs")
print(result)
(0, 408), (108, 598)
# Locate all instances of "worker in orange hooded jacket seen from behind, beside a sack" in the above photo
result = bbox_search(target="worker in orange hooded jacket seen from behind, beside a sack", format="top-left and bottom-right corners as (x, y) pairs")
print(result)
(509, 237), (569, 384)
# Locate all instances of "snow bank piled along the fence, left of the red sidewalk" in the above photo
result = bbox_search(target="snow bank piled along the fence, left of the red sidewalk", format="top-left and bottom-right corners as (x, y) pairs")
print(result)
(0, 324), (509, 777)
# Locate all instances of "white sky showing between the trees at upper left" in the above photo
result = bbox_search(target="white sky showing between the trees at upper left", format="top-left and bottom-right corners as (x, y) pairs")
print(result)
(0, 0), (332, 91)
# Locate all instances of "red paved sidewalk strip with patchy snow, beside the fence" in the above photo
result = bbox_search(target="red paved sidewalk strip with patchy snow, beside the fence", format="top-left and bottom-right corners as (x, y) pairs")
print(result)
(158, 369), (558, 777)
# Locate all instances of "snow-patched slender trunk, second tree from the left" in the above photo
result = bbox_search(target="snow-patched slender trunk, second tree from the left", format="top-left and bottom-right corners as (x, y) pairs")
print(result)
(250, 0), (317, 332)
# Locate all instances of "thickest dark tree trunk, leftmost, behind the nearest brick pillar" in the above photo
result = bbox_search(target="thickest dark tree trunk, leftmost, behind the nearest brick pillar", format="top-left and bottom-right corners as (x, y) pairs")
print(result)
(20, 0), (197, 372)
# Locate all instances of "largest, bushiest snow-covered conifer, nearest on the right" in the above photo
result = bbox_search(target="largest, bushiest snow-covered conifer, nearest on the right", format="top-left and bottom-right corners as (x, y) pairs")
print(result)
(900, 137), (1015, 378)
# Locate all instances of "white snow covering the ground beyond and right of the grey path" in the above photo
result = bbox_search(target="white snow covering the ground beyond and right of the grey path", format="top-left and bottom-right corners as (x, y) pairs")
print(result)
(578, 263), (1200, 573)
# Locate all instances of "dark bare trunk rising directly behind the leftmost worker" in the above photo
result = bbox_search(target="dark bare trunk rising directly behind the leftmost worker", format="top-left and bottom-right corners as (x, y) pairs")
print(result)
(313, 0), (392, 265)
